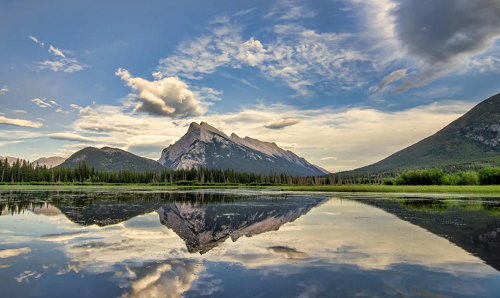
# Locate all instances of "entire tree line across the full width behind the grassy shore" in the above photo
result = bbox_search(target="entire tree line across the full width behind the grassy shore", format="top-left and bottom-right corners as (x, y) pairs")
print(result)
(0, 159), (500, 186)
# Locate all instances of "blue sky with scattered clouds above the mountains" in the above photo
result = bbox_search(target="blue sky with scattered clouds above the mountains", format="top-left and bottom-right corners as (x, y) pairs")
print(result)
(0, 0), (500, 171)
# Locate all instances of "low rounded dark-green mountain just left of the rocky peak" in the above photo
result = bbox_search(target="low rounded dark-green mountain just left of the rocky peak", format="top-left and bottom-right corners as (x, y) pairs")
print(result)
(58, 147), (165, 172)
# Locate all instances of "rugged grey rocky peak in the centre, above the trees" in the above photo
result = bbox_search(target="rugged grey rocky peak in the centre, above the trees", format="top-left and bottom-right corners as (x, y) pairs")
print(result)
(158, 122), (329, 176)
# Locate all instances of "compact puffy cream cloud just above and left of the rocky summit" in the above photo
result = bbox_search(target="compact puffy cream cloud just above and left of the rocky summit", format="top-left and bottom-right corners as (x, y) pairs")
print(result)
(116, 68), (204, 117)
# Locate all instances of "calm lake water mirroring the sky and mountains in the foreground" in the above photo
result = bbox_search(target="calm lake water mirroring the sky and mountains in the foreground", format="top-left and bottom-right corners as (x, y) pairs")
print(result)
(0, 190), (500, 298)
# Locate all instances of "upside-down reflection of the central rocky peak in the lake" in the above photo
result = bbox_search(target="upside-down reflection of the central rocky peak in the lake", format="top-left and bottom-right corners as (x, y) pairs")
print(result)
(156, 197), (327, 254)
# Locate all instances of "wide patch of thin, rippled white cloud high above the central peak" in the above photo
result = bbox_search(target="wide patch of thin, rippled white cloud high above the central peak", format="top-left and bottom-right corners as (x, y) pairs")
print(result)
(157, 16), (371, 97)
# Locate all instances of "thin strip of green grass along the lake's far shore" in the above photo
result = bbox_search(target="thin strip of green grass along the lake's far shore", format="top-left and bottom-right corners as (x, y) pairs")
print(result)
(0, 184), (500, 195)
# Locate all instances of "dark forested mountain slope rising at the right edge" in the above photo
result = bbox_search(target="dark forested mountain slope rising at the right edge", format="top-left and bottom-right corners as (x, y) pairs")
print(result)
(354, 94), (500, 172)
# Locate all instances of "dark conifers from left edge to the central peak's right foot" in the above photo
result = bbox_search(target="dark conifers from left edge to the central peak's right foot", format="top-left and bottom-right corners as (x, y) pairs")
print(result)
(0, 160), (332, 185)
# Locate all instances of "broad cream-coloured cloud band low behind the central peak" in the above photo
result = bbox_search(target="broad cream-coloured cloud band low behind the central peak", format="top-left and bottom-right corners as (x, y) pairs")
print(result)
(72, 101), (472, 171)
